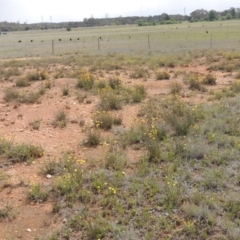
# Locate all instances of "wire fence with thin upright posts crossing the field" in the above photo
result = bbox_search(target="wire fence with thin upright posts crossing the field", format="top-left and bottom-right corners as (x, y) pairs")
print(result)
(0, 29), (240, 59)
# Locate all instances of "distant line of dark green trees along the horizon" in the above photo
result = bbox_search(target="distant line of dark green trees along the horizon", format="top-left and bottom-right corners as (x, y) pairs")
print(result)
(0, 7), (240, 32)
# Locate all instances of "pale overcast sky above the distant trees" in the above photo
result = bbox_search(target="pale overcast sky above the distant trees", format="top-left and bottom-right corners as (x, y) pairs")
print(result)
(0, 0), (240, 23)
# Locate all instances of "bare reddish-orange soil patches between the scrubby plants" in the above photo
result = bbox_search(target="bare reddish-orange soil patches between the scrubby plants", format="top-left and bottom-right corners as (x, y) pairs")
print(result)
(0, 66), (233, 240)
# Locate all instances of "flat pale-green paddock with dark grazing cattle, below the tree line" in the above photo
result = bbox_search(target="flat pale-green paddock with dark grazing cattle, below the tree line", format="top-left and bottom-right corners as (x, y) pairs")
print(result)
(0, 20), (240, 58)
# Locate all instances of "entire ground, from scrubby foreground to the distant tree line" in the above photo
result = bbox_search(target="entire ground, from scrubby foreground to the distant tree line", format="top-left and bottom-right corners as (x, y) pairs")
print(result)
(0, 21), (240, 240)
